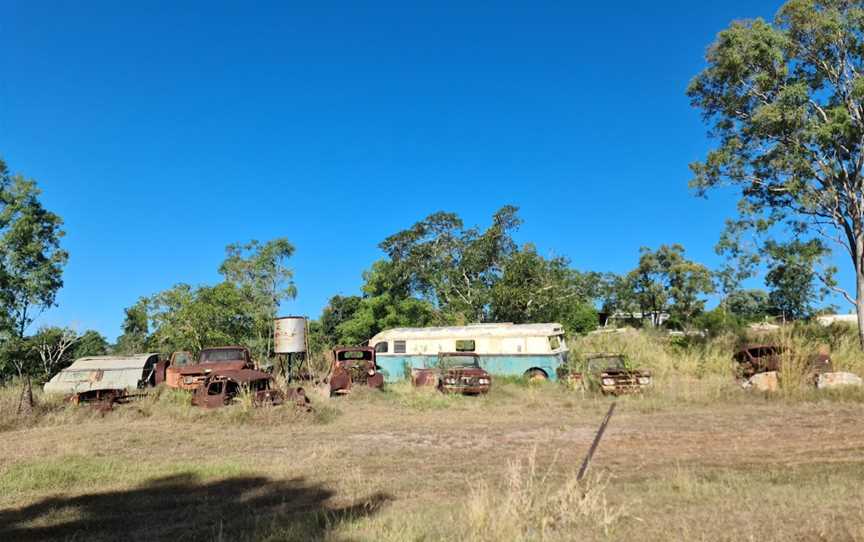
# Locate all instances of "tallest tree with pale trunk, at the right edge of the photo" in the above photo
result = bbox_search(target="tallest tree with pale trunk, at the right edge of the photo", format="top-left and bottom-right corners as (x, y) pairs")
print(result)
(687, 0), (864, 348)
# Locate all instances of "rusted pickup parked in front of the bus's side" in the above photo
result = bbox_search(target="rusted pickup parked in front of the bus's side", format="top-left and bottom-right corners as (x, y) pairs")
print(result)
(411, 352), (492, 395)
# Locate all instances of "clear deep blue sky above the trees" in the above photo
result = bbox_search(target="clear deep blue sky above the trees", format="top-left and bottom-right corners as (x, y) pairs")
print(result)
(0, 0), (845, 339)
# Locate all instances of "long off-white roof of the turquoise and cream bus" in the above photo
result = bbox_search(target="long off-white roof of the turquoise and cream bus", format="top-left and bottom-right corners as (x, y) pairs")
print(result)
(369, 323), (564, 345)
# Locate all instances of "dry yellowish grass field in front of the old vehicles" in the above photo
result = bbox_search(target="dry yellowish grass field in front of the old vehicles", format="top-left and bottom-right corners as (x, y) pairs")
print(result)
(0, 330), (864, 541)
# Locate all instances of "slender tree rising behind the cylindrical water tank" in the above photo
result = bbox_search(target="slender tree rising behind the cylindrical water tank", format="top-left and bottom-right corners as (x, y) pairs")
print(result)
(219, 238), (297, 359)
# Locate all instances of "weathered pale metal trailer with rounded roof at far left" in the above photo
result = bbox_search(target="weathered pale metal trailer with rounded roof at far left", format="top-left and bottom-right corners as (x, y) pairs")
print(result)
(44, 352), (159, 402)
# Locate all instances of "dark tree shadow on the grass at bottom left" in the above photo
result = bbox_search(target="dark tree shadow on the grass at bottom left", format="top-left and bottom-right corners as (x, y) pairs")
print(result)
(0, 474), (392, 540)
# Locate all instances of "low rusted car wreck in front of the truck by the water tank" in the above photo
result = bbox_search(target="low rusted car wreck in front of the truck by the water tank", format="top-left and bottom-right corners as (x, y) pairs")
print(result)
(192, 369), (309, 409)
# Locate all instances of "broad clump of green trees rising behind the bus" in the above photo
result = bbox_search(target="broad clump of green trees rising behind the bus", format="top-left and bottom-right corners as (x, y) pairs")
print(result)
(312, 207), (600, 351)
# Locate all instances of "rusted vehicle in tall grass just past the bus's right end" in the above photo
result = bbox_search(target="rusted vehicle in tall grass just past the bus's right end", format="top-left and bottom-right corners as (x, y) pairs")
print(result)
(559, 352), (653, 395)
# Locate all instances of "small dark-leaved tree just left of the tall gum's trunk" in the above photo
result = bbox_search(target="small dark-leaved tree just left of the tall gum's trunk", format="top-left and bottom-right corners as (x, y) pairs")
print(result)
(765, 239), (827, 320)
